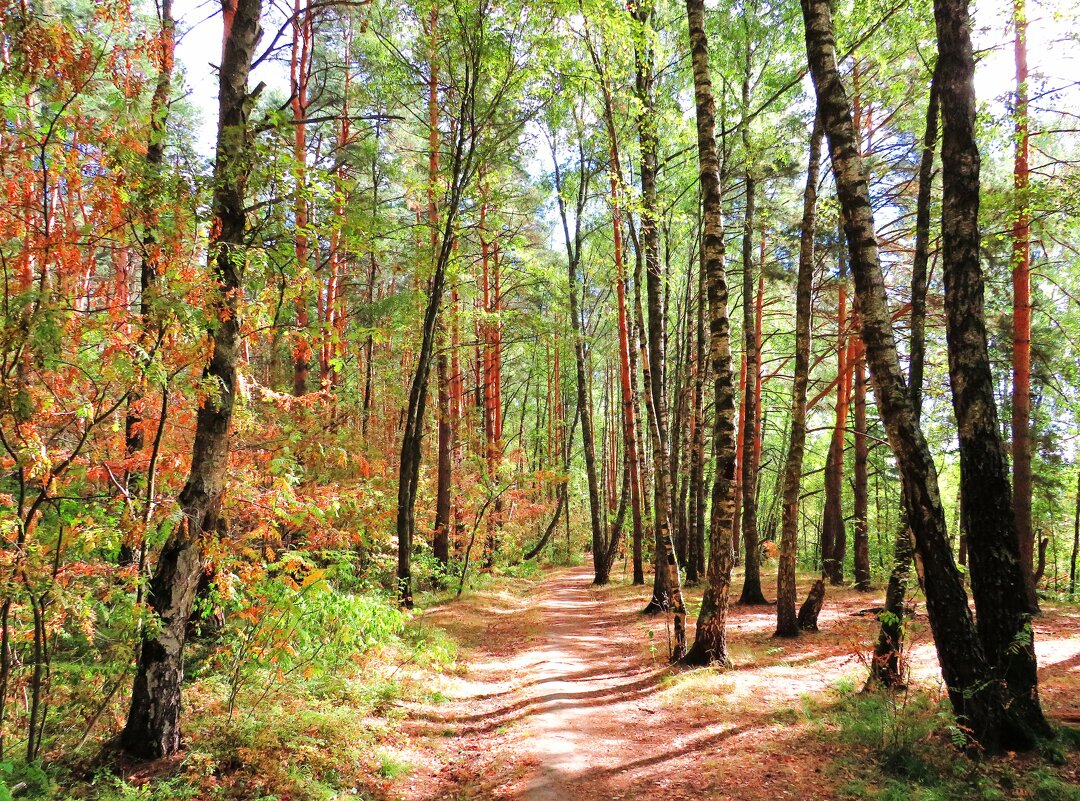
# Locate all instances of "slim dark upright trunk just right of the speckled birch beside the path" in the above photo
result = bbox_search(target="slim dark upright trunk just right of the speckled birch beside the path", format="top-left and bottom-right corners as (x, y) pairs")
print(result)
(739, 145), (766, 603)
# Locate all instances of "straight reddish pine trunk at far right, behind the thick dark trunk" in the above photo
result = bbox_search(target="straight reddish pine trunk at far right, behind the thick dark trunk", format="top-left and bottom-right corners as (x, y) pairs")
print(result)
(1012, 0), (1039, 613)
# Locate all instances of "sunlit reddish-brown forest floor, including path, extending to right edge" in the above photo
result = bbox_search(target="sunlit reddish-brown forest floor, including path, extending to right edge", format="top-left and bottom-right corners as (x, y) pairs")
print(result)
(383, 567), (1080, 801)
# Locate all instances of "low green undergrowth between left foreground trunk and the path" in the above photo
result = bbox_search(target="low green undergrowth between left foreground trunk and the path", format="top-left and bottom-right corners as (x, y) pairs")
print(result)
(19, 566), (458, 801)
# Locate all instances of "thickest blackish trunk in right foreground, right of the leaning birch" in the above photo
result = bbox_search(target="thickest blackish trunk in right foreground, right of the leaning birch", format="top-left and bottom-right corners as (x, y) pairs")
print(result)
(934, 0), (1051, 735)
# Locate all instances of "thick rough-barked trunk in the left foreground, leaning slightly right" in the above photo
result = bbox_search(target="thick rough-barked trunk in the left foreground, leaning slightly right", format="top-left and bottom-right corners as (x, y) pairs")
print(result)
(120, 0), (261, 759)
